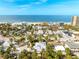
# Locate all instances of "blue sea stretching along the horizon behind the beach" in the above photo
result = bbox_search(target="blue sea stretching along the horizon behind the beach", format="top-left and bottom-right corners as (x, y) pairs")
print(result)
(0, 15), (71, 22)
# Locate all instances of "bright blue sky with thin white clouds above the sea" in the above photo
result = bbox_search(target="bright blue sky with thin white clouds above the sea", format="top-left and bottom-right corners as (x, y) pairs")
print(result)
(0, 0), (79, 15)
